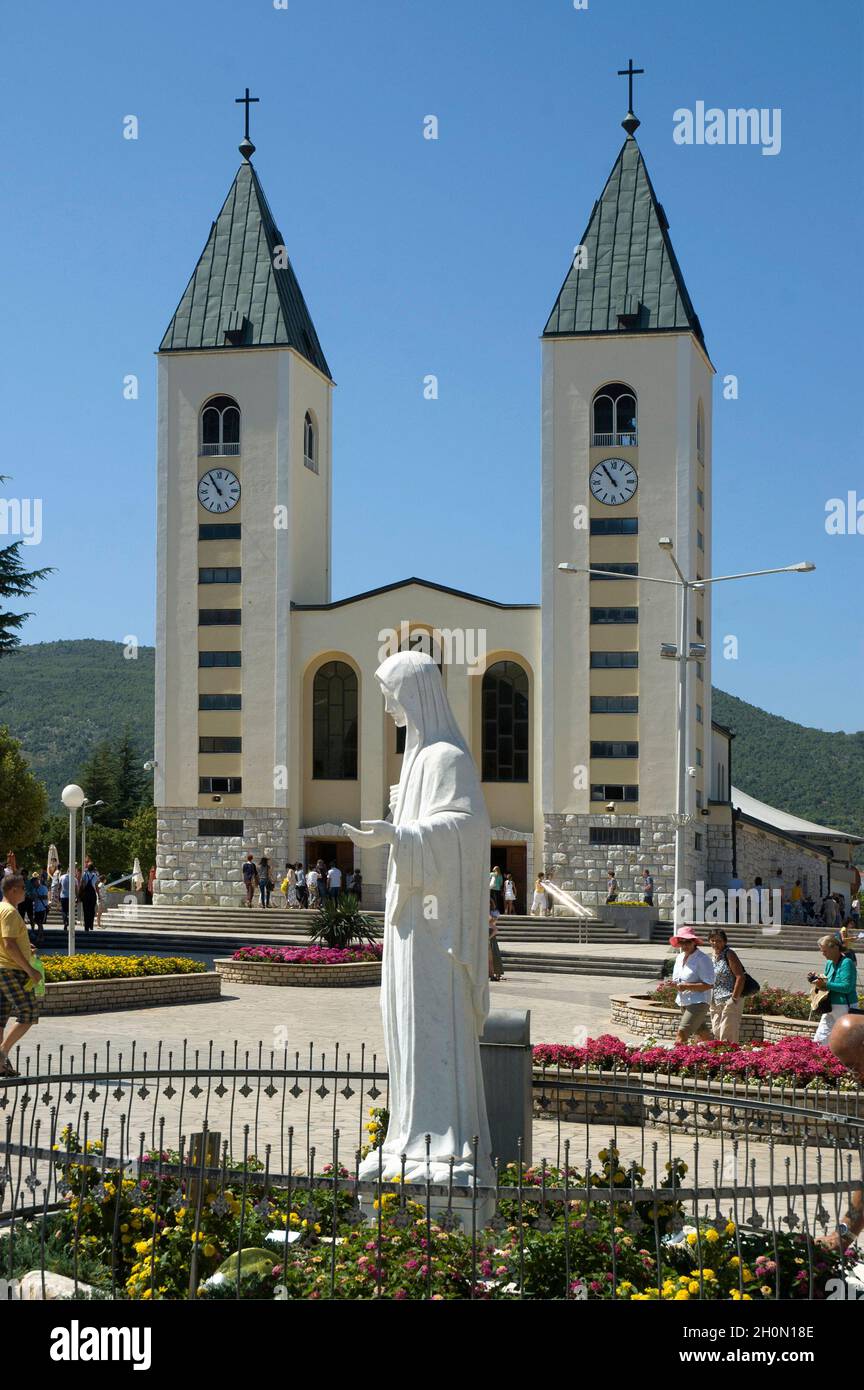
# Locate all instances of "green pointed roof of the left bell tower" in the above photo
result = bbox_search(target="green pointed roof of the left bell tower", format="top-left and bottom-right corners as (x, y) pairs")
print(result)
(160, 160), (331, 377)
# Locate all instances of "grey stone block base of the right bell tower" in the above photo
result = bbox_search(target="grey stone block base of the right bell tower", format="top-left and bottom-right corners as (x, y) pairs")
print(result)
(536, 812), (707, 915)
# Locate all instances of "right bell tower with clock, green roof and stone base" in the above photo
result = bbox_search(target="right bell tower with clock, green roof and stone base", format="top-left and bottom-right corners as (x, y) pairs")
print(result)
(542, 81), (714, 906)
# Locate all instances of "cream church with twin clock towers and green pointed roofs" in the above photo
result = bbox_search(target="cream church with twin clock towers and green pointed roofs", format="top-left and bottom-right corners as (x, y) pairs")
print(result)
(154, 115), (849, 910)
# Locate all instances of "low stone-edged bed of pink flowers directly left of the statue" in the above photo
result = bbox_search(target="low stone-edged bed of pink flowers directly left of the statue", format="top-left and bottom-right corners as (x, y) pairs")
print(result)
(215, 941), (383, 987)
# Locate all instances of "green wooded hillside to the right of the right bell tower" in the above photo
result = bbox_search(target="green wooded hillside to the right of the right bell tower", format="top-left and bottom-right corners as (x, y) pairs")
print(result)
(713, 689), (864, 835)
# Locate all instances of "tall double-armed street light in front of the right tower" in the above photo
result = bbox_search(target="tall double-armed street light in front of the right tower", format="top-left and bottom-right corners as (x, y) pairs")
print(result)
(558, 535), (815, 924)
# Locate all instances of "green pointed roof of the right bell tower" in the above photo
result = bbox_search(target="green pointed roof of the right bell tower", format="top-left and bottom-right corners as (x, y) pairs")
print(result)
(543, 135), (704, 348)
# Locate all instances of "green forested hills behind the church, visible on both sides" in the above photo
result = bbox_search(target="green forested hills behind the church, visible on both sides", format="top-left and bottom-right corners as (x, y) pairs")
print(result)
(0, 639), (864, 835)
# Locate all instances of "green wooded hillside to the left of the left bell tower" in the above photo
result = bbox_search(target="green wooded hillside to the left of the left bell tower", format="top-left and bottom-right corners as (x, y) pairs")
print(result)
(0, 638), (156, 810)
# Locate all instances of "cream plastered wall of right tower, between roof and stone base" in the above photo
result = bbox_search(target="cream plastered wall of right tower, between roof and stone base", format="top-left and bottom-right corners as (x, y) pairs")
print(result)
(542, 334), (713, 816)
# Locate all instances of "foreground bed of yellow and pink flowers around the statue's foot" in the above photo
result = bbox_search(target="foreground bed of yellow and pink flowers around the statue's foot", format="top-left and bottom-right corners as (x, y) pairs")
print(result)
(8, 1131), (853, 1301)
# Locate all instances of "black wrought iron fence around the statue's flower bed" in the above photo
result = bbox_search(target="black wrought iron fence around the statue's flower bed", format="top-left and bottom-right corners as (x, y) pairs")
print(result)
(0, 1044), (864, 1300)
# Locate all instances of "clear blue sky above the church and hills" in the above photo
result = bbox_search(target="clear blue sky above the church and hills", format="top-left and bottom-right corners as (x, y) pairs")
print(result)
(0, 0), (864, 730)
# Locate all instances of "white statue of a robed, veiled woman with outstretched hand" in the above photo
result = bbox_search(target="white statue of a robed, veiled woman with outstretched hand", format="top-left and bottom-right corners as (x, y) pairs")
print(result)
(344, 652), (492, 1186)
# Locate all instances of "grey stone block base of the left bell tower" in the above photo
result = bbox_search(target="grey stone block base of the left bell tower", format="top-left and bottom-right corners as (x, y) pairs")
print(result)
(153, 806), (292, 908)
